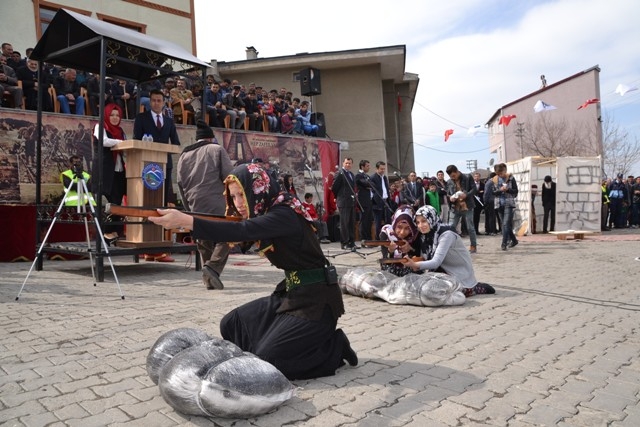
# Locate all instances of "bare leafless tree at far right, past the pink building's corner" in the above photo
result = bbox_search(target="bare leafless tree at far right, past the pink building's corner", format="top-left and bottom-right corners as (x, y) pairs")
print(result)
(602, 115), (640, 177)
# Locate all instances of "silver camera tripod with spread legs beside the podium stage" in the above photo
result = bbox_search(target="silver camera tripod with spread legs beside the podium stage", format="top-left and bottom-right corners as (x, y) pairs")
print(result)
(16, 169), (124, 301)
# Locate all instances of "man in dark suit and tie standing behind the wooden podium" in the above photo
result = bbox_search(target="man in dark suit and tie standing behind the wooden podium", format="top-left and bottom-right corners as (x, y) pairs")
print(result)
(133, 89), (180, 262)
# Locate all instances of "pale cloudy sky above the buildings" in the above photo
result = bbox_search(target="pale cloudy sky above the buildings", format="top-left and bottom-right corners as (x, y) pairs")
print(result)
(195, 0), (640, 175)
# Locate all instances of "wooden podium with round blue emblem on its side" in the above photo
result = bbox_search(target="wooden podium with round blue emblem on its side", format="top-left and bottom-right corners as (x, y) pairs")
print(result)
(112, 139), (180, 248)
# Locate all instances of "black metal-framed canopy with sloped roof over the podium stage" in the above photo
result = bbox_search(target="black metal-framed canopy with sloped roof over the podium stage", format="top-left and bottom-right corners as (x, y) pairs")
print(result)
(30, 9), (208, 281)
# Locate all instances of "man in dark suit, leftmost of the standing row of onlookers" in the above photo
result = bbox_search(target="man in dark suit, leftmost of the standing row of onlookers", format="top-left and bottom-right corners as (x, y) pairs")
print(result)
(331, 157), (356, 251)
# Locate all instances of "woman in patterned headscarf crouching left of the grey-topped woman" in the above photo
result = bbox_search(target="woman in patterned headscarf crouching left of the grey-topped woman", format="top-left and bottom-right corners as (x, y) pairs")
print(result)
(380, 206), (418, 277)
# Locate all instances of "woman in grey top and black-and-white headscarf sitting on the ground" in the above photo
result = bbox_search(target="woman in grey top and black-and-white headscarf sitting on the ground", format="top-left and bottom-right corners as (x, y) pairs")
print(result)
(404, 205), (496, 297)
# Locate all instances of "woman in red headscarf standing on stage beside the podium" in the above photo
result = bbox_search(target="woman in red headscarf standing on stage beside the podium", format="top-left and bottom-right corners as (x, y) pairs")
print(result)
(91, 104), (127, 243)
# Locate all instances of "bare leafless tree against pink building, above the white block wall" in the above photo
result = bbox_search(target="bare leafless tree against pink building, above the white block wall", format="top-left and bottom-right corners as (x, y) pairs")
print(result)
(521, 113), (599, 157)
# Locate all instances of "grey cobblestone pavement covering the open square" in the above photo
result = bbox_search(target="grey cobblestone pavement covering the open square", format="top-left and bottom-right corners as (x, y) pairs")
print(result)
(0, 230), (640, 427)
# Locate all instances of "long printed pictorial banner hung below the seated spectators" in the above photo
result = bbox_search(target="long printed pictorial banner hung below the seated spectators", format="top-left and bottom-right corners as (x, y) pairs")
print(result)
(0, 109), (340, 214)
